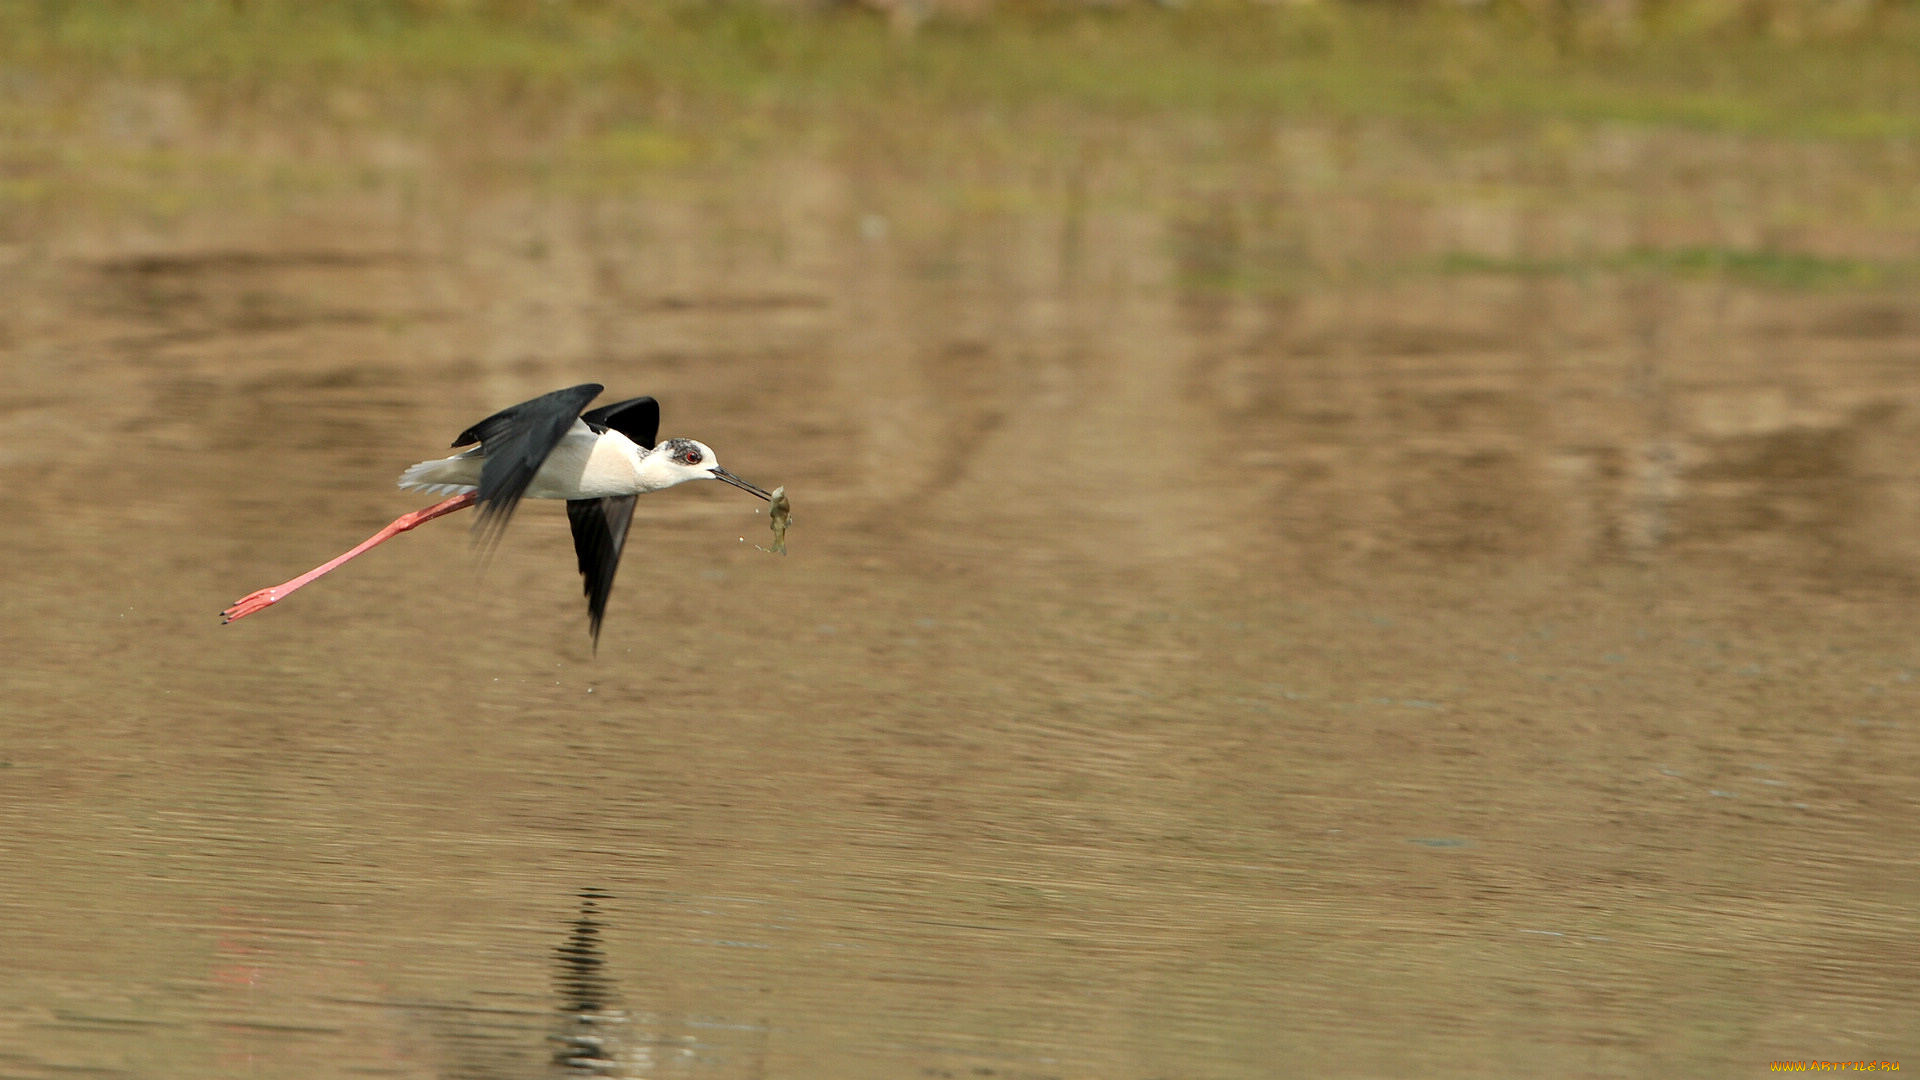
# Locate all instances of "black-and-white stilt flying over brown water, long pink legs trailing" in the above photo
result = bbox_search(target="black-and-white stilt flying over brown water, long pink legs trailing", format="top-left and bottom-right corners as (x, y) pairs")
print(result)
(221, 382), (772, 648)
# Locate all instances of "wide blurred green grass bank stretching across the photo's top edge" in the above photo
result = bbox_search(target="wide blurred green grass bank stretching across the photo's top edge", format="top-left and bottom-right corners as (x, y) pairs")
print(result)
(0, 0), (1920, 138)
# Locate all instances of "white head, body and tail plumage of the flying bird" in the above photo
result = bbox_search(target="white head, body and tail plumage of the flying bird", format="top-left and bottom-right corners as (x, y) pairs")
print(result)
(399, 421), (720, 500)
